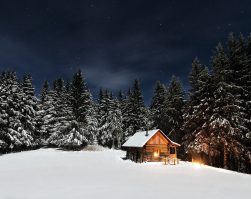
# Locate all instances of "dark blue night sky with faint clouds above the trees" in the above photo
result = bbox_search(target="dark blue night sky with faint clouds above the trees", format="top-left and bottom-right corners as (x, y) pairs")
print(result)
(0, 0), (251, 104)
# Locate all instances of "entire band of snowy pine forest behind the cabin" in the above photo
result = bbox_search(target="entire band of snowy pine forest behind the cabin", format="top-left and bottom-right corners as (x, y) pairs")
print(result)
(0, 34), (251, 173)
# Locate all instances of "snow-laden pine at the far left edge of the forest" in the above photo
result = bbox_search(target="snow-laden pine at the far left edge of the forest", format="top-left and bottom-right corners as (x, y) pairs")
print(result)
(0, 72), (34, 150)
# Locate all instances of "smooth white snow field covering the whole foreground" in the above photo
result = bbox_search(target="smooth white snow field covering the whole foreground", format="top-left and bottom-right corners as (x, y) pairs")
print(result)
(0, 149), (251, 199)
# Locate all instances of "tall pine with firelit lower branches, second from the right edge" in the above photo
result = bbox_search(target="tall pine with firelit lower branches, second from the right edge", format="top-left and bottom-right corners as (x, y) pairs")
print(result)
(209, 41), (245, 170)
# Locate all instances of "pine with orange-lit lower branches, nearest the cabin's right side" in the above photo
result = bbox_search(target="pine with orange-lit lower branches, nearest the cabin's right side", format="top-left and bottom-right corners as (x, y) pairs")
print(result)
(183, 68), (214, 164)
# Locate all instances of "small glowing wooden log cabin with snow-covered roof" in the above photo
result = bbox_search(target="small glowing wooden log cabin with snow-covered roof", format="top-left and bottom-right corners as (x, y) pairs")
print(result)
(122, 129), (180, 164)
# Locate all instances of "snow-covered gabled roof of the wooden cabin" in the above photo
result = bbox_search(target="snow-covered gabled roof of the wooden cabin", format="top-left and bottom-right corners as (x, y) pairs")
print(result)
(122, 129), (180, 147)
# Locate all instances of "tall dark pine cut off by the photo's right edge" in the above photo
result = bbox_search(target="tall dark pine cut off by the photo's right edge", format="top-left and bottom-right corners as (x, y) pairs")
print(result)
(227, 33), (251, 169)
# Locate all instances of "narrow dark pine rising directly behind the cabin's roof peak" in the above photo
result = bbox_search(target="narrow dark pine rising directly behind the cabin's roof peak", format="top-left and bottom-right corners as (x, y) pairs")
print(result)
(150, 81), (167, 129)
